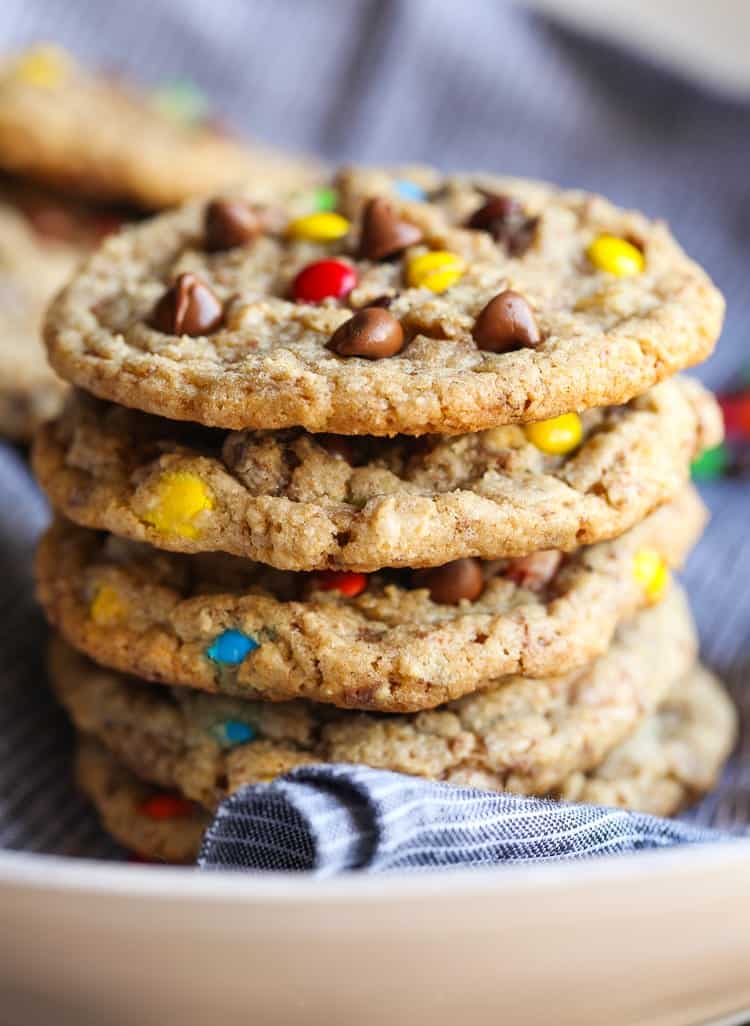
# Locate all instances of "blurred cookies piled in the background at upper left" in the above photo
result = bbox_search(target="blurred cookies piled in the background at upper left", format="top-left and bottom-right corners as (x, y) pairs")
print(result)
(0, 46), (317, 441)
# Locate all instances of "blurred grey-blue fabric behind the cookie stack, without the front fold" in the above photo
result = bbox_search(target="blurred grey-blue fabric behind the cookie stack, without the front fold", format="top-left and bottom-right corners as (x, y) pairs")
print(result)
(0, 0), (750, 855)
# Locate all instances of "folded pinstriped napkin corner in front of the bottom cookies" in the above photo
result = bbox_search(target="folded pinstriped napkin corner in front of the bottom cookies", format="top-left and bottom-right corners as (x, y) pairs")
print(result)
(198, 764), (733, 876)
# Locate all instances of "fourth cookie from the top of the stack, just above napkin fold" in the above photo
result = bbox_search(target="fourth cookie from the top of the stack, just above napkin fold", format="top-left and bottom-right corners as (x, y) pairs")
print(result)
(50, 588), (697, 808)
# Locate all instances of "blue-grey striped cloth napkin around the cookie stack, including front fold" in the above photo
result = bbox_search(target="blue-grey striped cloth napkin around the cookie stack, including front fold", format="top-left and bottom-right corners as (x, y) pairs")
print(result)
(0, 0), (750, 873)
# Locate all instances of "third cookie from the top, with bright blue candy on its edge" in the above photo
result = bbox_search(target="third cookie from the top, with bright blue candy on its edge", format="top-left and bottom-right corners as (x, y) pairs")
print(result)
(36, 490), (705, 712)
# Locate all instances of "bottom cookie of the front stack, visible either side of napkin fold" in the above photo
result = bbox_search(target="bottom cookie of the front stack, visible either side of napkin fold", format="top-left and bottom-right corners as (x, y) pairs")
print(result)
(71, 667), (736, 863)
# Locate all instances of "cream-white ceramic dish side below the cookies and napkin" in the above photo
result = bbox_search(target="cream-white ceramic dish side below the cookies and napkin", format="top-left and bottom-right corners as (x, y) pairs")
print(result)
(0, 841), (750, 1026)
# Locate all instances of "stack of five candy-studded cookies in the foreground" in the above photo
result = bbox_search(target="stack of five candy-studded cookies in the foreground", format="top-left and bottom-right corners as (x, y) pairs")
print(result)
(34, 169), (735, 861)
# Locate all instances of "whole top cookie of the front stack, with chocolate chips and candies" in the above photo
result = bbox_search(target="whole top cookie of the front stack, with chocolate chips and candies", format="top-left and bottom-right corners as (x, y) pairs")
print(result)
(46, 163), (723, 435)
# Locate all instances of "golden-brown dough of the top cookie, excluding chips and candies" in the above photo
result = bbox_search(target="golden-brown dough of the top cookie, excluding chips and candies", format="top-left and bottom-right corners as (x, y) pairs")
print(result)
(45, 167), (723, 435)
